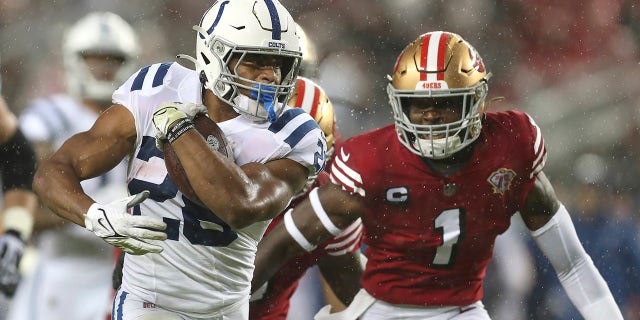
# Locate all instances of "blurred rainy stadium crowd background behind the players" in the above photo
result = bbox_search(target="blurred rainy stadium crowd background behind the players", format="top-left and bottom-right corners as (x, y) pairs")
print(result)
(0, 0), (640, 320)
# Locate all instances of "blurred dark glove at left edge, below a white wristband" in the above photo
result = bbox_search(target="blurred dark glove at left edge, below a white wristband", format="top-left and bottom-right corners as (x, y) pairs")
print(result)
(0, 231), (25, 297)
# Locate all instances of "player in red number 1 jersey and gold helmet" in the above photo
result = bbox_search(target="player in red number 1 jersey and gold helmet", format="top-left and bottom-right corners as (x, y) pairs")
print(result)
(253, 31), (622, 320)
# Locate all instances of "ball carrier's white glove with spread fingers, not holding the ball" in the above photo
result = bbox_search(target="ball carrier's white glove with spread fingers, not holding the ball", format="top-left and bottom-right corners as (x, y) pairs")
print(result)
(84, 191), (167, 255)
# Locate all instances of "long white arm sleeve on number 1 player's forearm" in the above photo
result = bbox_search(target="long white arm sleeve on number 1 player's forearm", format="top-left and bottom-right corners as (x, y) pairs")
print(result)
(531, 205), (623, 320)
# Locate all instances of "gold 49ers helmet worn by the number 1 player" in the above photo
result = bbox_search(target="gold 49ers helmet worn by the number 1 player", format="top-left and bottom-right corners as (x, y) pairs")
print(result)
(387, 31), (491, 159)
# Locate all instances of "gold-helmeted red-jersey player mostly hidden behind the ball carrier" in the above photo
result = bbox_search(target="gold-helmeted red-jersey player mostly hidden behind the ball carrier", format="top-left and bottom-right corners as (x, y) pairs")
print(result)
(249, 75), (363, 320)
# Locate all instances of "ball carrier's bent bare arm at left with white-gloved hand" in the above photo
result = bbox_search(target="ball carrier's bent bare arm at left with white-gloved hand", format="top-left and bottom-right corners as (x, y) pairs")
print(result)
(33, 105), (166, 254)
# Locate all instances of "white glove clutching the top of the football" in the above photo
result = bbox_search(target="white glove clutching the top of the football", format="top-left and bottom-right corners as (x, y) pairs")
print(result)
(153, 102), (207, 151)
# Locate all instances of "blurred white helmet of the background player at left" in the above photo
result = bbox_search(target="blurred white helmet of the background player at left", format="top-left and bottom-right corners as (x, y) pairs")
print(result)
(62, 12), (139, 102)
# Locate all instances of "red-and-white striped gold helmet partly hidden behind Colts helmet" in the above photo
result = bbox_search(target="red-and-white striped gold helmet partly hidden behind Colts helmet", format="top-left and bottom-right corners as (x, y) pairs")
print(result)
(287, 77), (336, 153)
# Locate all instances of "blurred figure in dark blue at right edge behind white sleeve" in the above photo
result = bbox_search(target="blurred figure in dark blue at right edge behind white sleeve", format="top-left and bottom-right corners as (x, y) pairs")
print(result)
(529, 172), (640, 320)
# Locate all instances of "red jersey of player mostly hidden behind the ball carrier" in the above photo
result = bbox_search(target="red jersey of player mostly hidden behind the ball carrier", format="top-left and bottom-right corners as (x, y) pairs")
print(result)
(249, 172), (362, 320)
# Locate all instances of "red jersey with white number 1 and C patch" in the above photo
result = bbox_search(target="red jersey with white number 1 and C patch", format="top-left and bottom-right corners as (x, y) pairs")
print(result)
(331, 111), (546, 306)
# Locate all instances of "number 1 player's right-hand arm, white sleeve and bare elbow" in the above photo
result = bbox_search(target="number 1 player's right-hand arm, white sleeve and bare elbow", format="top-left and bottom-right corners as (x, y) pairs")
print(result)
(520, 172), (622, 320)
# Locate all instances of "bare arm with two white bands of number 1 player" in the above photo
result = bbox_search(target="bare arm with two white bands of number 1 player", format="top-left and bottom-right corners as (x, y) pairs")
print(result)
(251, 183), (364, 291)
